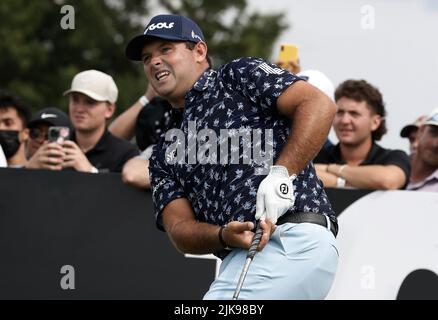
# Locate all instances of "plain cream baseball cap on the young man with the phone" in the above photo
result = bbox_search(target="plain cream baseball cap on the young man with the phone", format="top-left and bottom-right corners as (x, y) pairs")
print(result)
(64, 70), (119, 103)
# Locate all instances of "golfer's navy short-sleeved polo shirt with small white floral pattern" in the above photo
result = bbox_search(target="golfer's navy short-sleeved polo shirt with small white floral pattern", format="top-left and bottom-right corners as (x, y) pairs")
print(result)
(149, 58), (336, 230)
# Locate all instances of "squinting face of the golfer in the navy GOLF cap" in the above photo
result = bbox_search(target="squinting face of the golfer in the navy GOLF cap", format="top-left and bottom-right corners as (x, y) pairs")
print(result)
(142, 40), (198, 103)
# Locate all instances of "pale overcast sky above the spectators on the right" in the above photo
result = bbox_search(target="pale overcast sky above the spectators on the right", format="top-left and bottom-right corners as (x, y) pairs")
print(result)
(248, 0), (438, 151)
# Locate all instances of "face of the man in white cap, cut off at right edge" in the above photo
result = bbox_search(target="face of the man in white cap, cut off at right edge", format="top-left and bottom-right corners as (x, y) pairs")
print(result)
(417, 125), (438, 168)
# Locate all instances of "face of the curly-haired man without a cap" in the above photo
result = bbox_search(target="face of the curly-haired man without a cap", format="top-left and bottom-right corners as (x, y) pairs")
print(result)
(333, 97), (381, 146)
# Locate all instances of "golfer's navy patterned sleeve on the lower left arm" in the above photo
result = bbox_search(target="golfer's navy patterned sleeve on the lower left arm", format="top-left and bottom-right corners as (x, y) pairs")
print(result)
(149, 146), (186, 231)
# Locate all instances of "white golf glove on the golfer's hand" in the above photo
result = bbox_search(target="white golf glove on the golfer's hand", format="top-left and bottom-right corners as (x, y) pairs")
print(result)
(255, 166), (297, 224)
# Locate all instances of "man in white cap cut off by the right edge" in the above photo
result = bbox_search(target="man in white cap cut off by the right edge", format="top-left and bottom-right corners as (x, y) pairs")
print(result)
(406, 108), (438, 192)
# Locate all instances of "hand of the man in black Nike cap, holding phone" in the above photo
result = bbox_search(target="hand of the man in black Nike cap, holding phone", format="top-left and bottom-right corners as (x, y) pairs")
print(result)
(25, 141), (65, 170)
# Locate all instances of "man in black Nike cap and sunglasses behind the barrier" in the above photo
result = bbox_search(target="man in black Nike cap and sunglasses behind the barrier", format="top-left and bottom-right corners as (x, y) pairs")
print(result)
(26, 107), (71, 170)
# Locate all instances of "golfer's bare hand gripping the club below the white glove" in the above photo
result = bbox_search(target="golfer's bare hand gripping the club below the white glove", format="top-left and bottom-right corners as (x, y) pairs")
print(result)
(222, 220), (275, 251)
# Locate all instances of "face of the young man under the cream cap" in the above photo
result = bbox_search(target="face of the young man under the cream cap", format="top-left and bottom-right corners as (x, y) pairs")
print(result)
(69, 92), (115, 132)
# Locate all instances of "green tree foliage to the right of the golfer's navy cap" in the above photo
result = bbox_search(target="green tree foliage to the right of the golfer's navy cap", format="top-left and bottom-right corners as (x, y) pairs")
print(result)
(160, 0), (288, 66)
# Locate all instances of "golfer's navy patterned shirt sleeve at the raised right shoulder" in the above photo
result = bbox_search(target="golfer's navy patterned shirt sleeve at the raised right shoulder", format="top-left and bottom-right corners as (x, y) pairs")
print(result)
(220, 58), (303, 108)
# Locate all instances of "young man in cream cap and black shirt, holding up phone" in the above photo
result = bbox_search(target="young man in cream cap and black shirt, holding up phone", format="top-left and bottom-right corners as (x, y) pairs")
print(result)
(62, 70), (138, 173)
